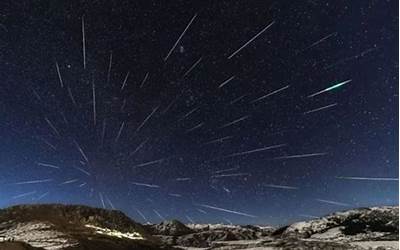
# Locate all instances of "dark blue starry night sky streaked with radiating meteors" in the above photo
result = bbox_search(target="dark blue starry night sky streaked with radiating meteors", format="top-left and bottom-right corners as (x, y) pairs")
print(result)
(0, 0), (399, 225)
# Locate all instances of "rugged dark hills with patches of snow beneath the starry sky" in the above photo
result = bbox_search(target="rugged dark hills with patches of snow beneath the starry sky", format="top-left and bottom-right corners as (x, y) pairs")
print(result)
(0, 204), (399, 250)
